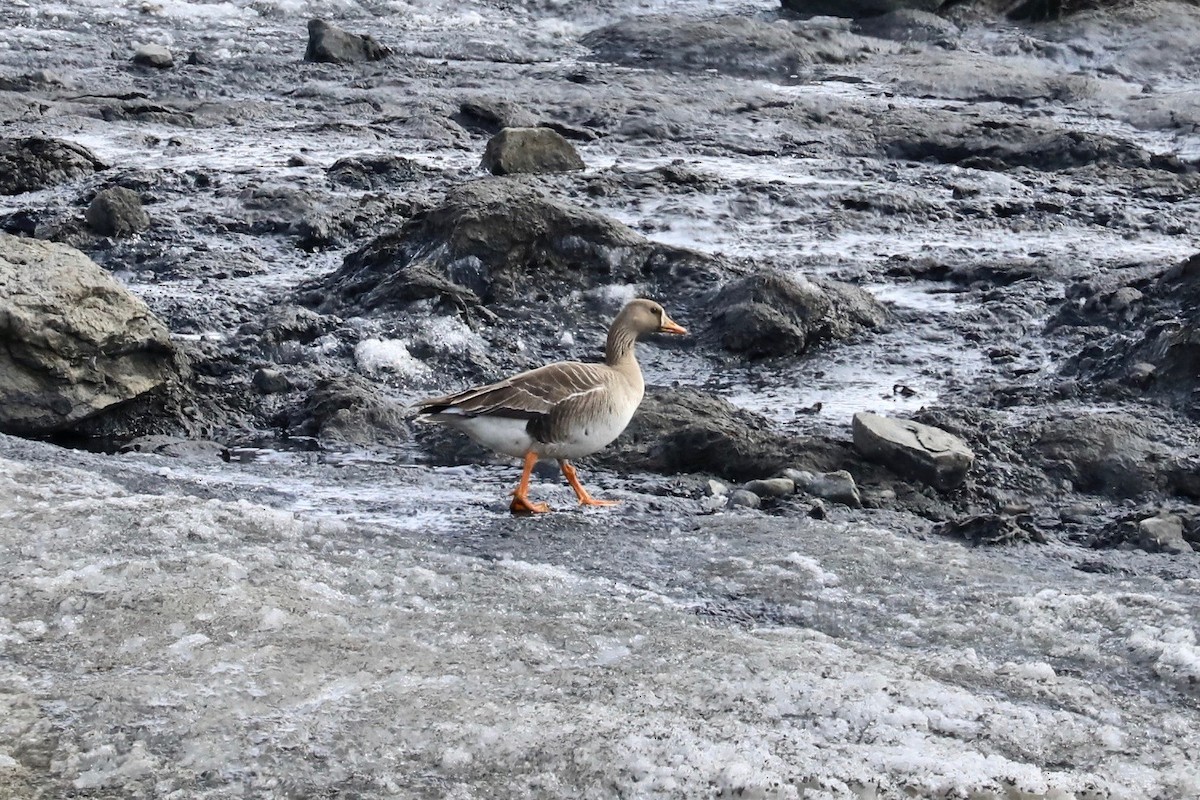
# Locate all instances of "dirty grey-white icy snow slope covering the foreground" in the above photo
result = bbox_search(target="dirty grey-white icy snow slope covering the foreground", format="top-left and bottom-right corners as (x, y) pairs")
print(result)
(0, 450), (1200, 800)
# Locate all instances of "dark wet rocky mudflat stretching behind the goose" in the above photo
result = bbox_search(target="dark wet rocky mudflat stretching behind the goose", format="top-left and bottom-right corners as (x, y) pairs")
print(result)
(0, 2), (1200, 552)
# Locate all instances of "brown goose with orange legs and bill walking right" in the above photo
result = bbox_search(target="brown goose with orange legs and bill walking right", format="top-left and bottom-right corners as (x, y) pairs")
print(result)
(415, 297), (688, 515)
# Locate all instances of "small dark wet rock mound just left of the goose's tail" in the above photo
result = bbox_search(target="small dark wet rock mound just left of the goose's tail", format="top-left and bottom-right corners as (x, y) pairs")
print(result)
(277, 375), (410, 446)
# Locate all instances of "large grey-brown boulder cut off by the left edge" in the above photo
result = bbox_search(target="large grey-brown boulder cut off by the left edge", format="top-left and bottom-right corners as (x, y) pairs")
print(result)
(0, 234), (180, 435)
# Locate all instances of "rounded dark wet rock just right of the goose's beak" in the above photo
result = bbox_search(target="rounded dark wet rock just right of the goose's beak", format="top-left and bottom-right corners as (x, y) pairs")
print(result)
(709, 272), (887, 359)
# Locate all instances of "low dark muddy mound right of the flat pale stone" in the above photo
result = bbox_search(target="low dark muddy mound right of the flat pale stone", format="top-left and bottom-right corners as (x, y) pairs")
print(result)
(1034, 411), (1176, 498)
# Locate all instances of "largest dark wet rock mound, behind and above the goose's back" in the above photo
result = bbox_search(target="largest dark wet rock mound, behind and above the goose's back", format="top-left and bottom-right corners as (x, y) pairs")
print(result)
(305, 178), (720, 319)
